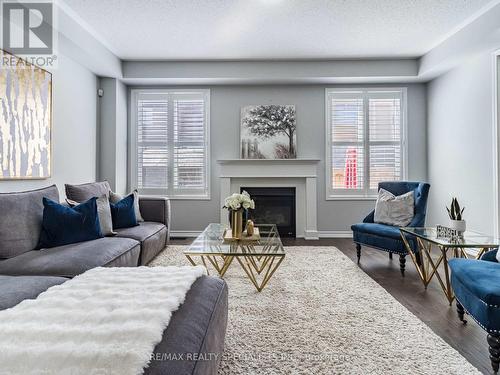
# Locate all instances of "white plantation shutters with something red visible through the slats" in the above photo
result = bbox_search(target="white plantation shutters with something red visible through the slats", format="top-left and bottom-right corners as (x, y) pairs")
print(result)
(326, 89), (404, 197)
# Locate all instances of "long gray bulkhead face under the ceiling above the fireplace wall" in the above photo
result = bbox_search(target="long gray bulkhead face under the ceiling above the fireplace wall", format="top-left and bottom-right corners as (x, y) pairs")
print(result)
(122, 58), (419, 86)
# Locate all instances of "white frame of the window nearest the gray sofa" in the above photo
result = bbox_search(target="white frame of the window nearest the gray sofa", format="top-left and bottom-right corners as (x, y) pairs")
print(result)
(128, 88), (211, 200)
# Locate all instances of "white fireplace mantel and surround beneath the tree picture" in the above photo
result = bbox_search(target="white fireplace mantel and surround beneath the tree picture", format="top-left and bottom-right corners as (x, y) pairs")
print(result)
(217, 159), (320, 240)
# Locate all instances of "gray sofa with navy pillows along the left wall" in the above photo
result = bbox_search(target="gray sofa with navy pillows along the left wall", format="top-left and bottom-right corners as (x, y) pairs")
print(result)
(0, 182), (170, 277)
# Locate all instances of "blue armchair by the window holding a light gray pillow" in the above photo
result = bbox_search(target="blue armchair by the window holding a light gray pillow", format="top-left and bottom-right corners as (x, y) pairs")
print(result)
(351, 181), (430, 276)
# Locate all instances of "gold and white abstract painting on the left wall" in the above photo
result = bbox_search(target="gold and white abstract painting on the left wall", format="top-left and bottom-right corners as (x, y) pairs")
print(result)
(0, 50), (52, 180)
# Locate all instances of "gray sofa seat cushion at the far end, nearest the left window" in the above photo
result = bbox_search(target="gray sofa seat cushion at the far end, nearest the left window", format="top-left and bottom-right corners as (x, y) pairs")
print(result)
(116, 221), (167, 265)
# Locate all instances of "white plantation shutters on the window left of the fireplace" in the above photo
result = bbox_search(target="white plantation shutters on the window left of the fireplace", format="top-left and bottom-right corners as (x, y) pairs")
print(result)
(131, 90), (209, 198)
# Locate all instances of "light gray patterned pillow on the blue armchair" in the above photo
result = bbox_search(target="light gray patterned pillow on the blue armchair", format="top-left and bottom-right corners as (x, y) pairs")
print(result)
(373, 189), (415, 227)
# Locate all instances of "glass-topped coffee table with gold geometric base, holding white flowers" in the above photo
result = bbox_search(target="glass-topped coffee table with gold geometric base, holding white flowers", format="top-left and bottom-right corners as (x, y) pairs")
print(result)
(184, 224), (285, 292)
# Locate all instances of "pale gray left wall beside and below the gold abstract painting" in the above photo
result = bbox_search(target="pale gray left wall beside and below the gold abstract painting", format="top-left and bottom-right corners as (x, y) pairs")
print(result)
(0, 55), (97, 197)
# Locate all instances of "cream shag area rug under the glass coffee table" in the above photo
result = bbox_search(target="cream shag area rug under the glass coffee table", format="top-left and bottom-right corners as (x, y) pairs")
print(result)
(151, 246), (479, 375)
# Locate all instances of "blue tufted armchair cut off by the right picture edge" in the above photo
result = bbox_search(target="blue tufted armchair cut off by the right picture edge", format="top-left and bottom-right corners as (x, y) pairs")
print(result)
(449, 250), (500, 373)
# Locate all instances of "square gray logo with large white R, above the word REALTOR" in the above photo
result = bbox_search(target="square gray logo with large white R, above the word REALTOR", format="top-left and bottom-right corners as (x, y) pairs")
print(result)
(2, 0), (54, 55)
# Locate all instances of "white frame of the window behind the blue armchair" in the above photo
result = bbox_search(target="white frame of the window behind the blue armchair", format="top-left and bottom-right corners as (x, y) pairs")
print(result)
(325, 87), (408, 200)
